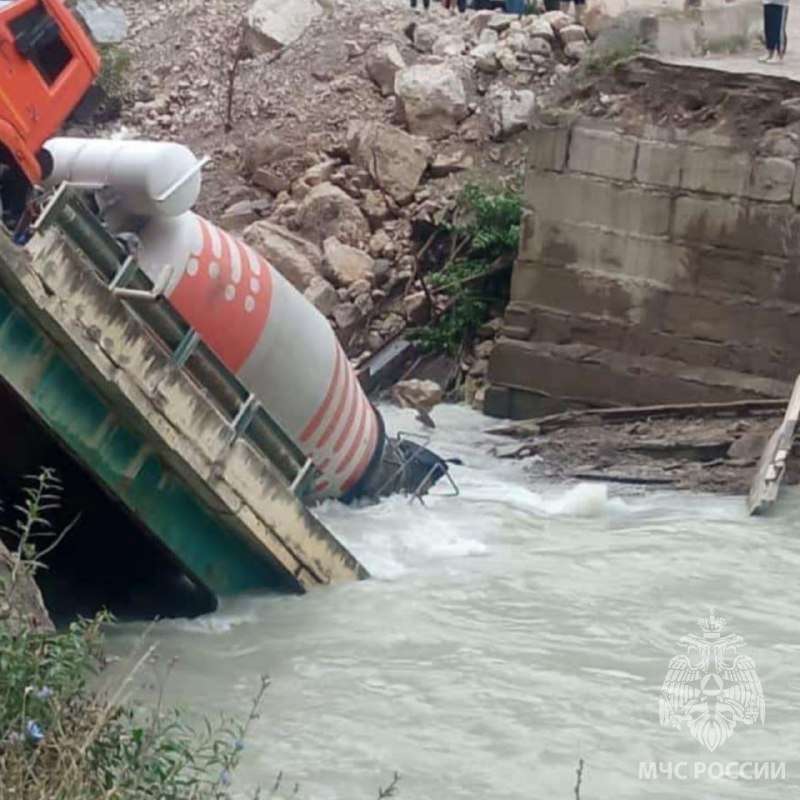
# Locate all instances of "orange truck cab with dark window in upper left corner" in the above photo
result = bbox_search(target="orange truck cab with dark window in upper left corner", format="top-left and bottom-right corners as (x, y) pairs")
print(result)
(0, 0), (100, 225)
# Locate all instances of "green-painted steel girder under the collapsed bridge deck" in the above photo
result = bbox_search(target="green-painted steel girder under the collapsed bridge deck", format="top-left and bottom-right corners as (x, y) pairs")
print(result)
(0, 290), (281, 595)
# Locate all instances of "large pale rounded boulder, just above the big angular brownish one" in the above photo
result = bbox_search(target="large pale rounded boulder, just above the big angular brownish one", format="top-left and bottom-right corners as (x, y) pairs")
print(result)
(394, 64), (469, 139)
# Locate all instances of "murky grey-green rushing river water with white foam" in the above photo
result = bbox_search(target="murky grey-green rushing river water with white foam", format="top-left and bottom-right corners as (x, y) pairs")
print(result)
(115, 407), (800, 800)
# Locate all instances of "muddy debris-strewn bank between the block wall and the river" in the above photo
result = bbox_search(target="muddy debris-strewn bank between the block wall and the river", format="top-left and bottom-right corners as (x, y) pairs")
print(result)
(488, 401), (800, 495)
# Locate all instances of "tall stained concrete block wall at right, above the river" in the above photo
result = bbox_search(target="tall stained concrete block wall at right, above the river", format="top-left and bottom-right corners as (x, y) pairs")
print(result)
(486, 117), (800, 416)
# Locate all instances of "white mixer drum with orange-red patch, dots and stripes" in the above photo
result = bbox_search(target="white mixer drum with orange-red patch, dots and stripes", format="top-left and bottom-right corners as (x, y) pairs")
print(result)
(139, 212), (383, 497)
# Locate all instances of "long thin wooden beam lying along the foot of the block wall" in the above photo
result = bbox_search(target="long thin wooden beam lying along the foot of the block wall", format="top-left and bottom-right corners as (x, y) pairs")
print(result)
(484, 399), (786, 436)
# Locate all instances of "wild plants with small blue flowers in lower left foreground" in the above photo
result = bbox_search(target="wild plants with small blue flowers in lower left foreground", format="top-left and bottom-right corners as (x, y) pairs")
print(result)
(0, 470), (268, 800)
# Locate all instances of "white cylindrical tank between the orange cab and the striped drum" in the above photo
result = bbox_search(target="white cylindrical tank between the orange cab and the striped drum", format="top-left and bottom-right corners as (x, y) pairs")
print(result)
(45, 137), (202, 217)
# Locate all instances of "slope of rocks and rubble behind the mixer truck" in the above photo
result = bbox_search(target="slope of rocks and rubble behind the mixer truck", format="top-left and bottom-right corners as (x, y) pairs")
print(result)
(97, 0), (600, 400)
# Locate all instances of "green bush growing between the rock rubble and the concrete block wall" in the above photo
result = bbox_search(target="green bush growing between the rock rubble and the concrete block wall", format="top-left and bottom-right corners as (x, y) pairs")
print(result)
(409, 184), (522, 353)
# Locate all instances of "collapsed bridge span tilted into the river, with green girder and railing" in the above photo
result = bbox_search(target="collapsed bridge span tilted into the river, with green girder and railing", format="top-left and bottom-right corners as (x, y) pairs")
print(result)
(0, 191), (366, 616)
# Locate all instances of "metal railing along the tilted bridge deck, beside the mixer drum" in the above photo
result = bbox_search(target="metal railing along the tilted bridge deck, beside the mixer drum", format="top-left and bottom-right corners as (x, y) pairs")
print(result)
(33, 183), (317, 498)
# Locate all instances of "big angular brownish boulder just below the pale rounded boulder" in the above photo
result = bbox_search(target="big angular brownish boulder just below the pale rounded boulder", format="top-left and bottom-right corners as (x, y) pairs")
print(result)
(347, 122), (433, 204)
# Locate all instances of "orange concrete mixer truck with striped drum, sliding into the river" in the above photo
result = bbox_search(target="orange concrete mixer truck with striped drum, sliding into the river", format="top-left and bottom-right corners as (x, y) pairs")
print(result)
(0, 0), (456, 502)
